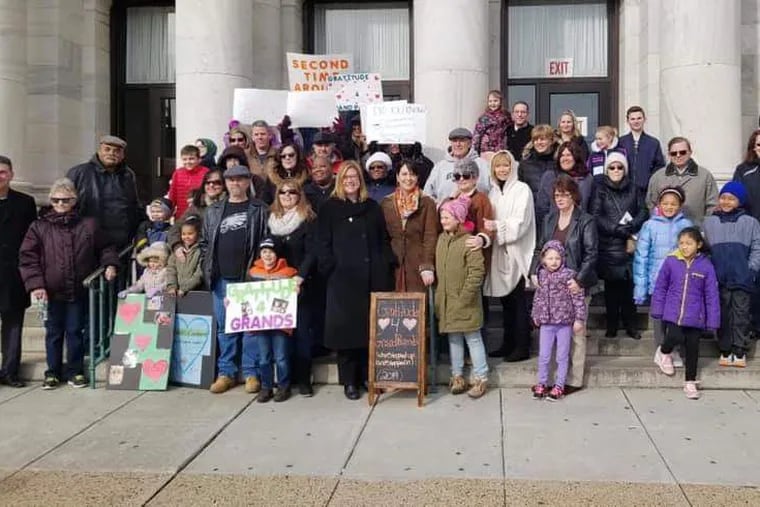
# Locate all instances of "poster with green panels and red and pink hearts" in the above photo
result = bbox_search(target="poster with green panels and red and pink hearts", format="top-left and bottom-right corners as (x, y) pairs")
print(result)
(106, 294), (175, 391)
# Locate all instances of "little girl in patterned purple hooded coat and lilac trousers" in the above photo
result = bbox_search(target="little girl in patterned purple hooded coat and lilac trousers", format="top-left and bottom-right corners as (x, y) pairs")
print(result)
(531, 240), (586, 401)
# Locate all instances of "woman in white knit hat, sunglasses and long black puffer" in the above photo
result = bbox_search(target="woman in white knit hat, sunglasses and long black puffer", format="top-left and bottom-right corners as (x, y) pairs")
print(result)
(591, 152), (649, 340)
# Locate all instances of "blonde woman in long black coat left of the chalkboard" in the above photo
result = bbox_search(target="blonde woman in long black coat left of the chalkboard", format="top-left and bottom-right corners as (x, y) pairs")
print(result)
(317, 161), (395, 400)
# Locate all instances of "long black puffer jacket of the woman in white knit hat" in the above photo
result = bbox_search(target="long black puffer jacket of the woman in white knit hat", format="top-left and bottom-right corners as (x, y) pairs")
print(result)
(591, 176), (649, 280)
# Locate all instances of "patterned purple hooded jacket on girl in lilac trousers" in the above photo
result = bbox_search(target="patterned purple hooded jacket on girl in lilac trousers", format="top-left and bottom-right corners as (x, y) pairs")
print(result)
(531, 240), (586, 326)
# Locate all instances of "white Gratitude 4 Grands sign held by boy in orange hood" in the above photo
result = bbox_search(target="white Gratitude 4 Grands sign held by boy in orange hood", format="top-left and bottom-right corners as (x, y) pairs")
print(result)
(224, 278), (298, 333)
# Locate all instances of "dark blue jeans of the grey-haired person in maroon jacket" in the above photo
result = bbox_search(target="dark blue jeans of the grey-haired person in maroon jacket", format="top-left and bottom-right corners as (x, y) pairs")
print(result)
(45, 299), (86, 378)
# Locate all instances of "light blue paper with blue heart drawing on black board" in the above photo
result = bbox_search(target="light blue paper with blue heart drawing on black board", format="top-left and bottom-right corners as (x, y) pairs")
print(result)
(172, 314), (211, 384)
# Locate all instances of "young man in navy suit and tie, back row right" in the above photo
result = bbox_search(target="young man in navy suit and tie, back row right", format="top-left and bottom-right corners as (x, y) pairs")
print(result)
(619, 106), (665, 192)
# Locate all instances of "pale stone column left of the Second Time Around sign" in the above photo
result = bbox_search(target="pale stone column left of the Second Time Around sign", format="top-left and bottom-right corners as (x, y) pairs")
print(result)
(175, 0), (255, 154)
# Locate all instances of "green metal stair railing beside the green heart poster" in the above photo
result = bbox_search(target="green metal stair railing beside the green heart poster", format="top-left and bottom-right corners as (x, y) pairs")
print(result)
(82, 245), (135, 389)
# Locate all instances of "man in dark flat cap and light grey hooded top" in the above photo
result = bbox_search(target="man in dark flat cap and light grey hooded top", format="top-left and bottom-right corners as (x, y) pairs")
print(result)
(423, 127), (491, 205)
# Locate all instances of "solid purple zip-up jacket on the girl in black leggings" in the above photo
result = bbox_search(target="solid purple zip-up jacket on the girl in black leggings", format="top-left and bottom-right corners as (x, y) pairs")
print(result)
(651, 250), (720, 330)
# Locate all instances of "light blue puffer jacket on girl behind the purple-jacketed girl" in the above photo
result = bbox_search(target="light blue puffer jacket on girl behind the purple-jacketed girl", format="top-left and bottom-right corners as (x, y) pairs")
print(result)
(633, 212), (694, 304)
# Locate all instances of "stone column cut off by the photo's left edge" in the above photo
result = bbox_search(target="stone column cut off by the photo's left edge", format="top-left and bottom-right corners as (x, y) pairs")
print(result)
(0, 0), (27, 181)
